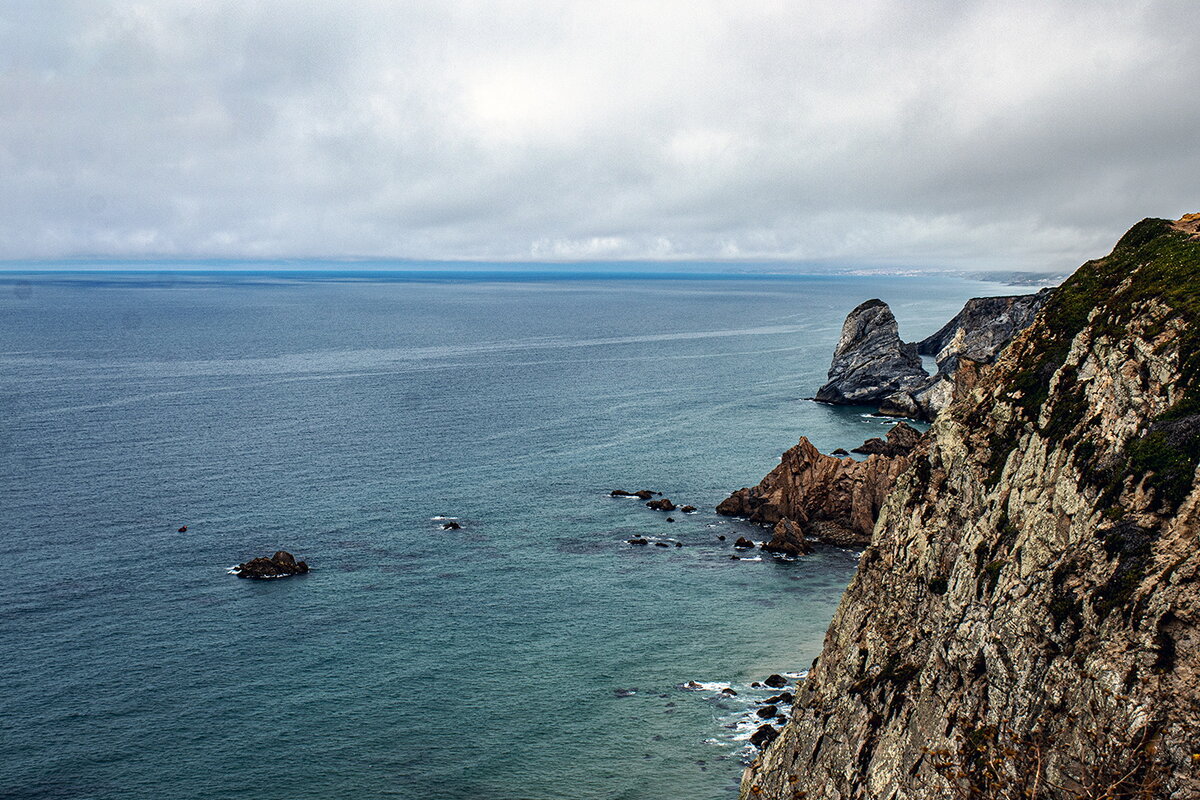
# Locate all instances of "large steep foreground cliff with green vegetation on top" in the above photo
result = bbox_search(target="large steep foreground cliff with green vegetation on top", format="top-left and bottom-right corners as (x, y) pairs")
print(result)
(742, 219), (1200, 800)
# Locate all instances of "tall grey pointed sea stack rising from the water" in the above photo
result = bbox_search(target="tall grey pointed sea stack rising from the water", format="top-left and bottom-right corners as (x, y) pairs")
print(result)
(816, 300), (929, 405)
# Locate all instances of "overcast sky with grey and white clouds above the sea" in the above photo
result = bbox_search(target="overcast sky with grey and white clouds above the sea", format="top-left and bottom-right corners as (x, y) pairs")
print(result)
(0, 0), (1200, 271)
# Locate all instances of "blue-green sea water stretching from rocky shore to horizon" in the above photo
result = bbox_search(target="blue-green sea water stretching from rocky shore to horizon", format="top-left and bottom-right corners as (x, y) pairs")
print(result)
(0, 273), (1004, 800)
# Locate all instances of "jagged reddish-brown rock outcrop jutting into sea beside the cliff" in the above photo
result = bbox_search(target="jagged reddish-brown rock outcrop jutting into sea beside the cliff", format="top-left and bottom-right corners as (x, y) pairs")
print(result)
(716, 422), (920, 547)
